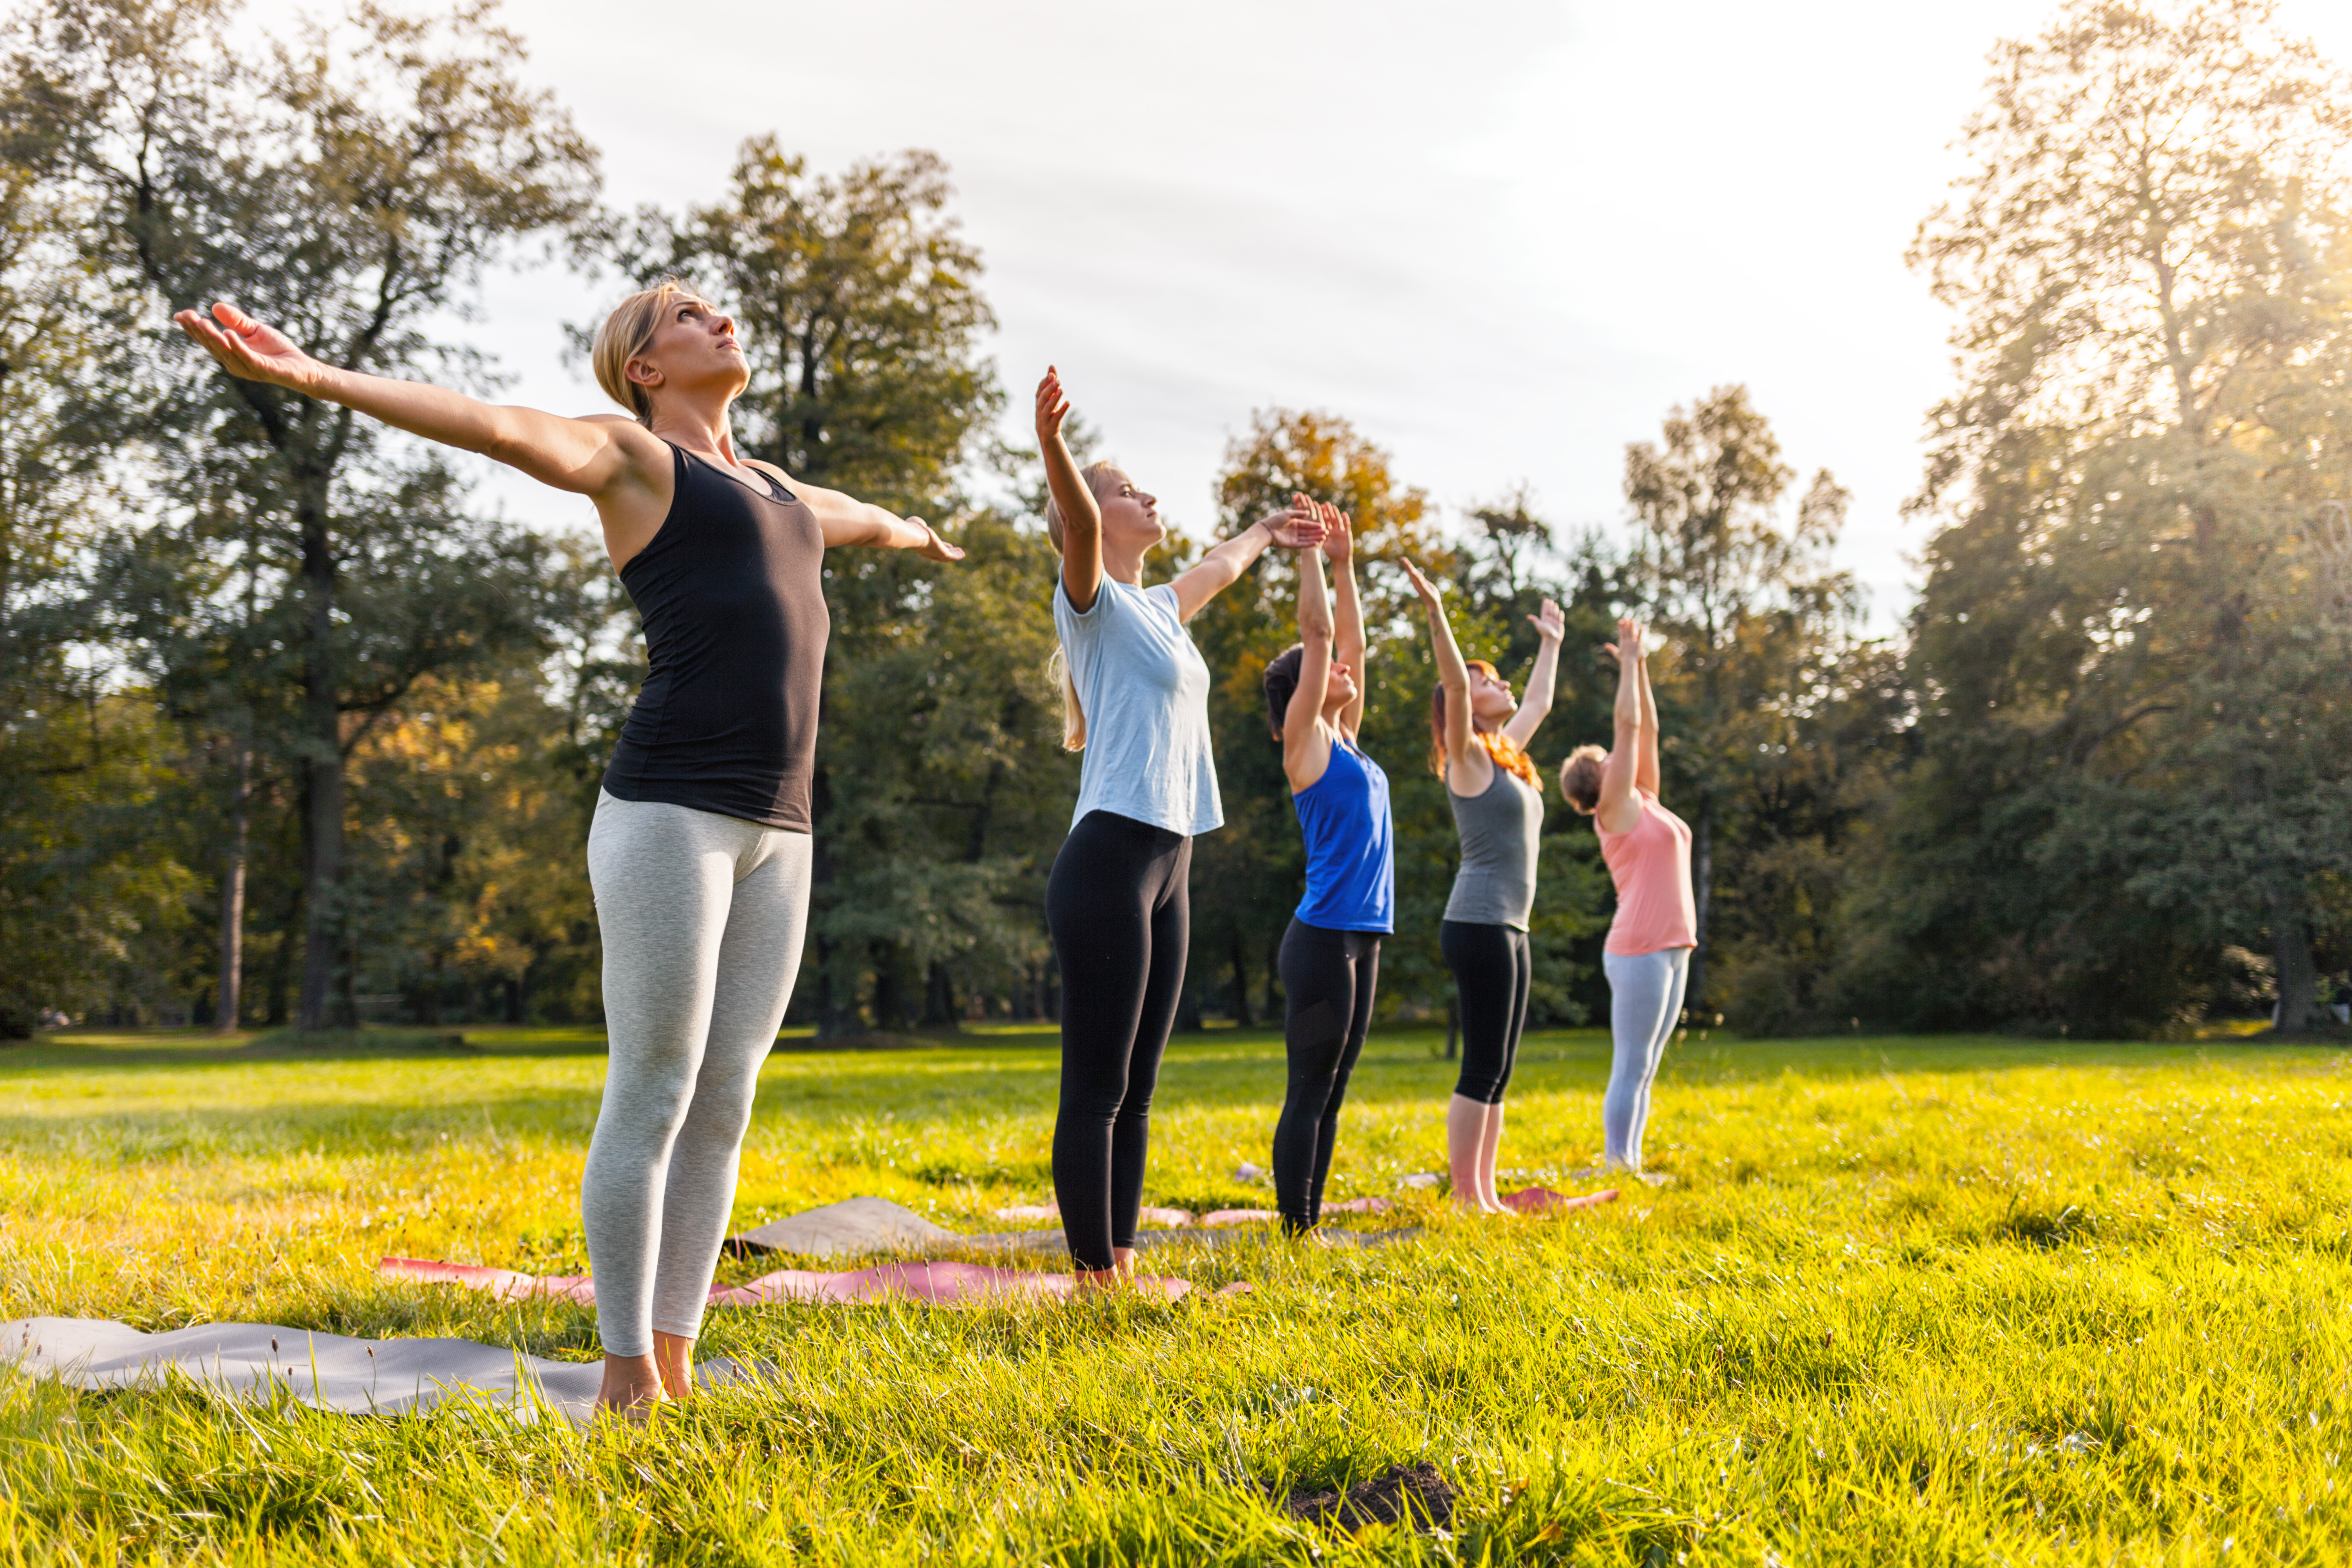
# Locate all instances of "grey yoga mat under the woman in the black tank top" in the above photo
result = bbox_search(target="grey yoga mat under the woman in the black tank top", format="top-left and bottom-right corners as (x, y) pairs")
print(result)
(0, 1316), (757, 1425)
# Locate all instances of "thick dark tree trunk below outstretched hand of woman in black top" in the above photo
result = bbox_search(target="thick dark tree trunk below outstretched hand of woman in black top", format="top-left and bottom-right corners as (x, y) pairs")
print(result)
(294, 501), (343, 1030)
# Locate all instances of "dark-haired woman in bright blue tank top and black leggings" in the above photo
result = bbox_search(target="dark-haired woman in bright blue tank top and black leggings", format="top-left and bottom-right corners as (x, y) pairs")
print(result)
(1265, 505), (1397, 1237)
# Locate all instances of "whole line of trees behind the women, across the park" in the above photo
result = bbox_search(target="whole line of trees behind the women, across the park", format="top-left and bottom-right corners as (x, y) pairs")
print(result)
(0, 0), (2352, 1034)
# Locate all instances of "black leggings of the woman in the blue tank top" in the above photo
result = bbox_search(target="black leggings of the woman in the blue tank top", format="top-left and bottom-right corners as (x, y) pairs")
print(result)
(1275, 919), (1381, 1234)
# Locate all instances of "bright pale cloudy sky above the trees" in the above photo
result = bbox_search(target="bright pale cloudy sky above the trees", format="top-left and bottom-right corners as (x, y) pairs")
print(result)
(254, 0), (2352, 630)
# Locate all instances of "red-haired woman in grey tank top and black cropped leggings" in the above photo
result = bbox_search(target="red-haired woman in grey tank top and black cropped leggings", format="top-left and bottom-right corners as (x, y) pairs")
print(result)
(1404, 562), (1566, 1213)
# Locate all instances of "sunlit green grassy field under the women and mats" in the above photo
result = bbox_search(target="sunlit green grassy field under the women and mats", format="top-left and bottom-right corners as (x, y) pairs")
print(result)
(0, 1030), (2352, 1565)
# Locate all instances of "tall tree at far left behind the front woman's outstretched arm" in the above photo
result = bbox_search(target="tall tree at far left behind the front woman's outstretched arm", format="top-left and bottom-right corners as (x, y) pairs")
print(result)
(0, 0), (595, 1027)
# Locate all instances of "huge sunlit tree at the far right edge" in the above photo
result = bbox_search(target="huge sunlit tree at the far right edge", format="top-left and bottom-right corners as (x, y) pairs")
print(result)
(1882, 0), (2352, 1032)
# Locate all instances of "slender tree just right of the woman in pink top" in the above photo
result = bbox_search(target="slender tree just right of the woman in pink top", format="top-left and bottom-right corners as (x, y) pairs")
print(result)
(1625, 386), (1856, 1011)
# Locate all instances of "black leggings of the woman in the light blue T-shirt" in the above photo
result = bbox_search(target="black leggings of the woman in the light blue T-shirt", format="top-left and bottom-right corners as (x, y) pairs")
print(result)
(1044, 811), (1192, 1269)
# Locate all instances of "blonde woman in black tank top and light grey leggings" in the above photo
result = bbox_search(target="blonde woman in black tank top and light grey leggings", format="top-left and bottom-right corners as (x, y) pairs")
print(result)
(174, 280), (962, 1415)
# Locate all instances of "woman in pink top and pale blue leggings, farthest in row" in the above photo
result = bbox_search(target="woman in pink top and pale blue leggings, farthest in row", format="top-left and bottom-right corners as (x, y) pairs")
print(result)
(1559, 618), (1698, 1185)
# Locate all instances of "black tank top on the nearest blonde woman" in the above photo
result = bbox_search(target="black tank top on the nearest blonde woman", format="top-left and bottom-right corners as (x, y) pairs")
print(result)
(604, 447), (833, 832)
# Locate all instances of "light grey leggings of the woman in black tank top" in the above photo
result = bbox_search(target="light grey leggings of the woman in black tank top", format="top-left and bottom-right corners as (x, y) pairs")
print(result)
(581, 792), (812, 1357)
